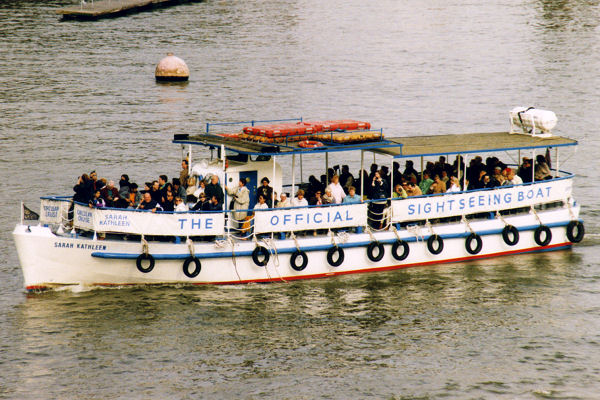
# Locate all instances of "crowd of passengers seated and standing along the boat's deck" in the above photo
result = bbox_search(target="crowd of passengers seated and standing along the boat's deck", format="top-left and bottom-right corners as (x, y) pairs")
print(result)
(73, 155), (552, 212)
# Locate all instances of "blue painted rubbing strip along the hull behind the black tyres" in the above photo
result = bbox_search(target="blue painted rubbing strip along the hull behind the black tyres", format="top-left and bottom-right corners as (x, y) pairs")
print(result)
(92, 221), (570, 260)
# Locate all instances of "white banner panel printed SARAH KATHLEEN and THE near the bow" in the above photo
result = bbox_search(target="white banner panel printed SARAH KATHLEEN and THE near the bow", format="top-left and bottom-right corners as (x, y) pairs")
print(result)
(73, 204), (225, 236)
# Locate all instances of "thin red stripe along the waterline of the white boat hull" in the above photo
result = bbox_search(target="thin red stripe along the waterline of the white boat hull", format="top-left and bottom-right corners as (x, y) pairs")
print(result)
(25, 242), (572, 291)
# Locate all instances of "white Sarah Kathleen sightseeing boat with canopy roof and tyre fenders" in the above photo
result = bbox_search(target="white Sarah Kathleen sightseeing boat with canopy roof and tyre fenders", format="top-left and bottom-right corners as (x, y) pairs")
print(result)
(13, 108), (584, 290)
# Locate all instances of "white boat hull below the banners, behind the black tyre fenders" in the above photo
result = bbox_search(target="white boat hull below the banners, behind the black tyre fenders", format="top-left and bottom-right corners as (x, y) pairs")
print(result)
(13, 206), (579, 290)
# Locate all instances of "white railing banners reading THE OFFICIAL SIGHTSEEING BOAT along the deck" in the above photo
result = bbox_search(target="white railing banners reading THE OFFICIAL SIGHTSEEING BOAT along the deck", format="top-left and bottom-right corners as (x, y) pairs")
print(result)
(40, 175), (572, 239)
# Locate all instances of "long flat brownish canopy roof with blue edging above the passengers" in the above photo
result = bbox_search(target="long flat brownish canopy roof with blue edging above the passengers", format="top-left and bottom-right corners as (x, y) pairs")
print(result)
(173, 132), (578, 158)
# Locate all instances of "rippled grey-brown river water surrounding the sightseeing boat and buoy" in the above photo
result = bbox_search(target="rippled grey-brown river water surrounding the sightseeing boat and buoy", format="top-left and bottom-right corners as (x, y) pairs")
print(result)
(0, 0), (600, 399)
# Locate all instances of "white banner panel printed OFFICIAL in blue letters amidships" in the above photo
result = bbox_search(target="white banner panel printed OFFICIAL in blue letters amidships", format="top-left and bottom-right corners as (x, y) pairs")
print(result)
(254, 203), (367, 233)
